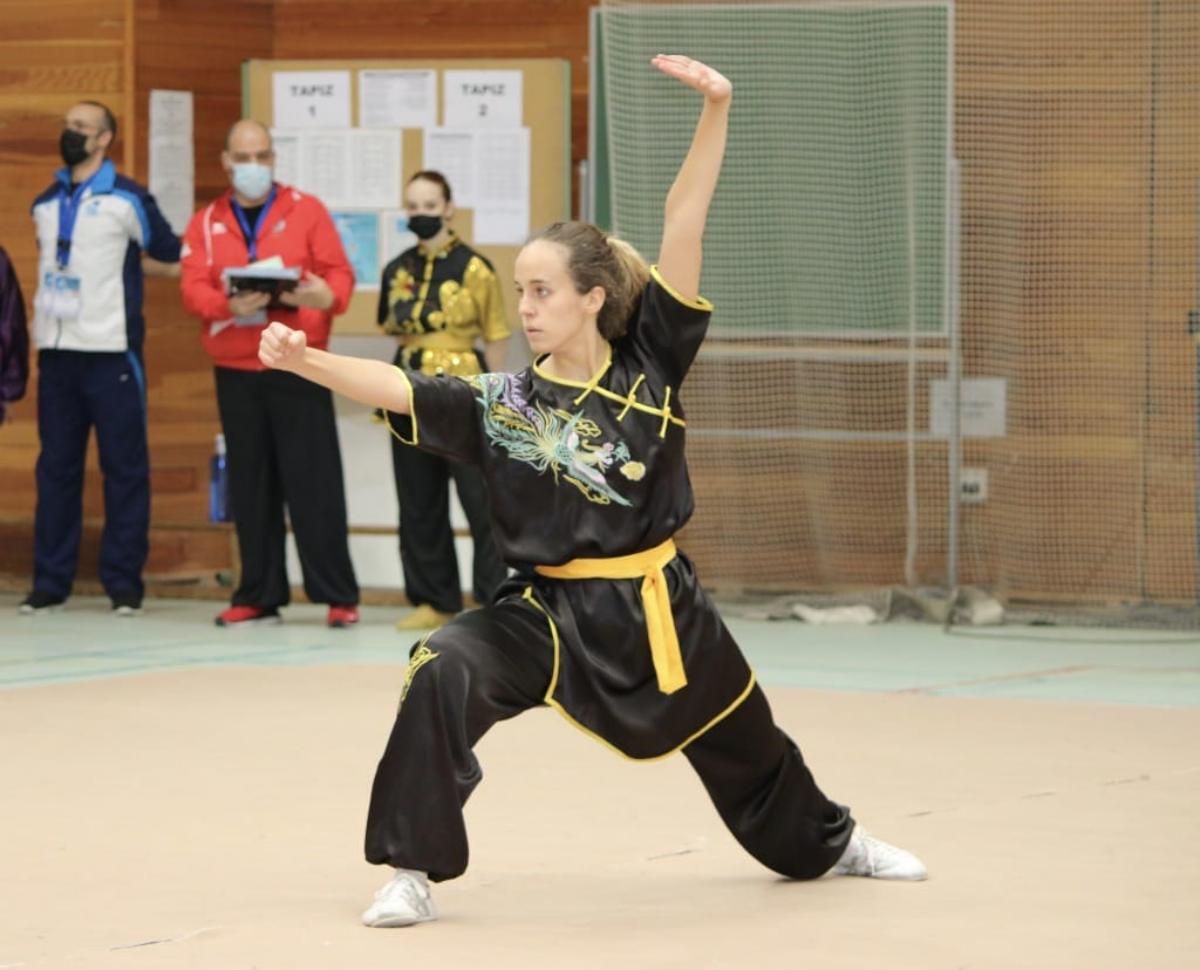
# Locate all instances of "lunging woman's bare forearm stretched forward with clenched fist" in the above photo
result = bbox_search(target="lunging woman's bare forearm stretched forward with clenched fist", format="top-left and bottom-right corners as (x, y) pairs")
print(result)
(258, 323), (412, 414)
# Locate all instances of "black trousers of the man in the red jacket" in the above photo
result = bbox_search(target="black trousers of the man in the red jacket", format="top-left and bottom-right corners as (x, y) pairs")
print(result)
(216, 367), (359, 607)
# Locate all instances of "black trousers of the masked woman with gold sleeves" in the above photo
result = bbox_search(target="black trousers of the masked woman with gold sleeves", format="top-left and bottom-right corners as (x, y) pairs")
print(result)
(391, 427), (508, 613)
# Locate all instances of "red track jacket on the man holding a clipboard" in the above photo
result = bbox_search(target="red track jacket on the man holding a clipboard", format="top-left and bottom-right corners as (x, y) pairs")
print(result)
(180, 184), (354, 371)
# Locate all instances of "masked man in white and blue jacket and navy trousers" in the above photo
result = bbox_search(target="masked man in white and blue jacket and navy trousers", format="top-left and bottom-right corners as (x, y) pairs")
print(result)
(20, 101), (180, 616)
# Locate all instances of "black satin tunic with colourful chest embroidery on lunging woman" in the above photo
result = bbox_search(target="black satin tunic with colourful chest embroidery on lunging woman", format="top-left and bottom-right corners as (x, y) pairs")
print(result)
(396, 271), (754, 759)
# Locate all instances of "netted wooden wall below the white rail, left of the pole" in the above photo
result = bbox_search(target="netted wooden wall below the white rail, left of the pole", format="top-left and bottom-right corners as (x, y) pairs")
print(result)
(680, 439), (946, 591)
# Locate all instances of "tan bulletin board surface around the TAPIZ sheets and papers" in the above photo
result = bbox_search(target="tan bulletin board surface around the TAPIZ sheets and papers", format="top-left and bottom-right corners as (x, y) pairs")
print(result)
(242, 59), (571, 335)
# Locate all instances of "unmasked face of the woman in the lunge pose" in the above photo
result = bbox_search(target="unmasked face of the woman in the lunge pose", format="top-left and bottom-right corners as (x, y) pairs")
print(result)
(516, 239), (605, 354)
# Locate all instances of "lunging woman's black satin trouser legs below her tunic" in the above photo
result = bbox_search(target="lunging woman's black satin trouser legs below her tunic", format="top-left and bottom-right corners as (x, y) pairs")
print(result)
(366, 600), (854, 881)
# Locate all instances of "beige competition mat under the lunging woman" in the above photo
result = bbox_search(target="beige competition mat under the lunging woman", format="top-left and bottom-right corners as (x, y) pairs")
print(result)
(0, 665), (1200, 970)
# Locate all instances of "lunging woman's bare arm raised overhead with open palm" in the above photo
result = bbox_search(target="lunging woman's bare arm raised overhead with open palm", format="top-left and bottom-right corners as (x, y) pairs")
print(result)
(652, 54), (733, 300)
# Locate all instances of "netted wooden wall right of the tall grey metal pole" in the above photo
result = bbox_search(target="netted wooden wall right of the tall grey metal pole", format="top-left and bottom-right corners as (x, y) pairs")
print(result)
(955, 0), (1200, 601)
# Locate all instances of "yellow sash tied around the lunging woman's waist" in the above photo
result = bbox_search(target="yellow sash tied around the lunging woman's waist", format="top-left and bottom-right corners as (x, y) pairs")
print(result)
(534, 539), (688, 694)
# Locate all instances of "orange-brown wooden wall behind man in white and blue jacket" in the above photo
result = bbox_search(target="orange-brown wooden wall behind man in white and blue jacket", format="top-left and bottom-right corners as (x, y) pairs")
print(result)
(0, 0), (272, 588)
